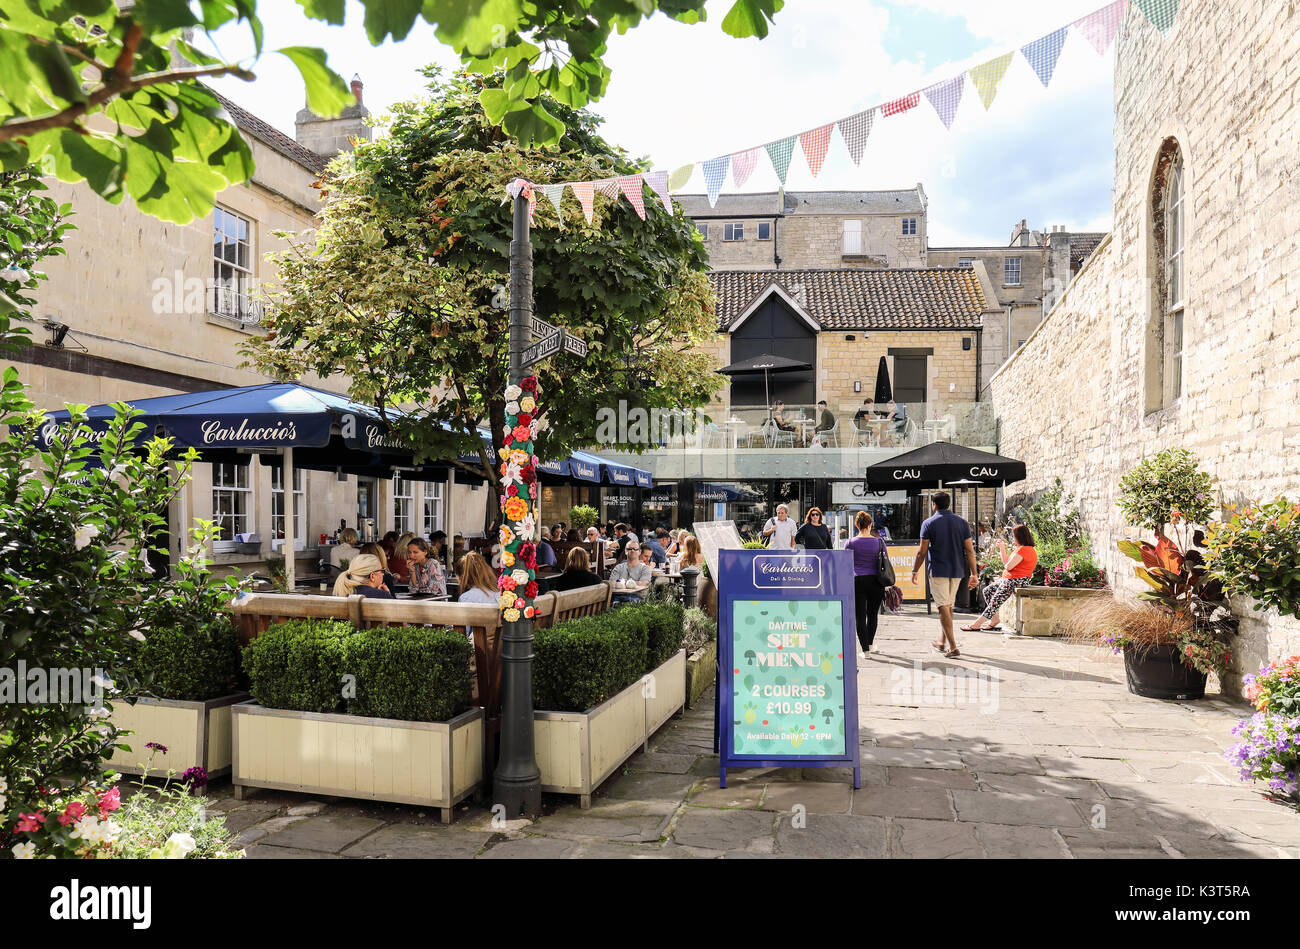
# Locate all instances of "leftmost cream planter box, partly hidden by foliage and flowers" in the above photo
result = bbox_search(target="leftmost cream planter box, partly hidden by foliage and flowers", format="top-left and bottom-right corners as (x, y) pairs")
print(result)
(107, 692), (248, 777)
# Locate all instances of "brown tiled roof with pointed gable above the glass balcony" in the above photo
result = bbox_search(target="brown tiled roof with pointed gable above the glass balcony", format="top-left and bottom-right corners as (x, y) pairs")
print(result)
(709, 267), (989, 330)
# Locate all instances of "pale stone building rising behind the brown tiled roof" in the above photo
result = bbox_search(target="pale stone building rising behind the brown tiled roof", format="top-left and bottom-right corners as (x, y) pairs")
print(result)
(673, 185), (928, 270)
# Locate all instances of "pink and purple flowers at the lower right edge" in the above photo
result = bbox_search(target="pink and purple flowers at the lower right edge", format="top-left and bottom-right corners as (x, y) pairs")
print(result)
(1225, 655), (1300, 810)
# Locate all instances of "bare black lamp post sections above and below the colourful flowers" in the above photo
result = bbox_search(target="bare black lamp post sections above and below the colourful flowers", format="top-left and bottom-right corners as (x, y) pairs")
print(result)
(493, 187), (542, 818)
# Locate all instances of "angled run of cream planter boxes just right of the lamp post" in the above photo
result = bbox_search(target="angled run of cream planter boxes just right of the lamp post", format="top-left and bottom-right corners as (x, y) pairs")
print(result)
(533, 649), (686, 807)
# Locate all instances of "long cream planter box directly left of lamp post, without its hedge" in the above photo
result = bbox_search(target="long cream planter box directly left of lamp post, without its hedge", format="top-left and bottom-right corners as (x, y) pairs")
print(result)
(231, 702), (484, 824)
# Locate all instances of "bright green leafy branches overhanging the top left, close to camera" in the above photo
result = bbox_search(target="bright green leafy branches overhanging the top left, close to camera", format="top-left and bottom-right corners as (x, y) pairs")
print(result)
(0, 0), (783, 224)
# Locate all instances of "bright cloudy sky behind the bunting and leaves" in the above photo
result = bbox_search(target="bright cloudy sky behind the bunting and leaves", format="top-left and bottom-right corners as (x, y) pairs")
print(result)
(202, 0), (1114, 247)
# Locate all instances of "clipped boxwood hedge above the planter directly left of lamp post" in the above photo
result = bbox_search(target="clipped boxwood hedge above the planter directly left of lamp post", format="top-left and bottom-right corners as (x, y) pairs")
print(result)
(243, 620), (469, 722)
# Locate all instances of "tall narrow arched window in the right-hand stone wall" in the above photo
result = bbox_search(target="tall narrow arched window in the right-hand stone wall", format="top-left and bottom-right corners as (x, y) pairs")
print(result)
(1147, 139), (1191, 411)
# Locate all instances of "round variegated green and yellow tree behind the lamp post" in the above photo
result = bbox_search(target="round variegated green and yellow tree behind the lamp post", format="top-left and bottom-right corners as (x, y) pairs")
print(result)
(247, 70), (719, 514)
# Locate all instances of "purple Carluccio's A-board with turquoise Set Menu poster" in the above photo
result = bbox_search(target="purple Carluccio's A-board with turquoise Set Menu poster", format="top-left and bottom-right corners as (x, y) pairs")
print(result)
(718, 550), (861, 788)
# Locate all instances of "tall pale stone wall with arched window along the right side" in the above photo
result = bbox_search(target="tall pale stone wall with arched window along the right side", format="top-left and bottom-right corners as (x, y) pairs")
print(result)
(992, 0), (1300, 690)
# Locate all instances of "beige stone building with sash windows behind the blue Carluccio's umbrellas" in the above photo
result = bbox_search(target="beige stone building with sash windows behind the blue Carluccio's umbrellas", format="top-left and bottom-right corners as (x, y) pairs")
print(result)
(8, 81), (485, 573)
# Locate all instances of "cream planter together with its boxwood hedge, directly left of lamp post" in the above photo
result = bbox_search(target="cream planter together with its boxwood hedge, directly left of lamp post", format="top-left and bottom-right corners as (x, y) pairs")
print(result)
(231, 620), (484, 823)
